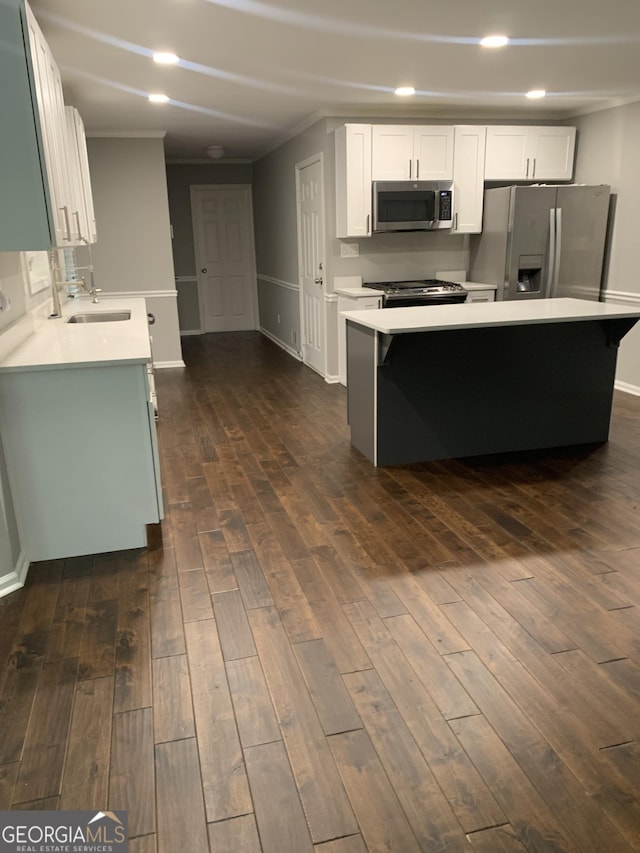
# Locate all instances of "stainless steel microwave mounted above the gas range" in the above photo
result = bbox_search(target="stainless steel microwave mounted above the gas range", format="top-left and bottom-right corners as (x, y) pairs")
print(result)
(372, 181), (453, 232)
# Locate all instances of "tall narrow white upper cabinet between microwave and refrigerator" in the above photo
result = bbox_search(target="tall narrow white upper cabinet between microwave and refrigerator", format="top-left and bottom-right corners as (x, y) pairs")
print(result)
(451, 125), (487, 234)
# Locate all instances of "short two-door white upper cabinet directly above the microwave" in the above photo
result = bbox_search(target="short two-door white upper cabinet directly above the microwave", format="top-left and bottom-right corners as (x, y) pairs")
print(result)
(371, 124), (453, 181)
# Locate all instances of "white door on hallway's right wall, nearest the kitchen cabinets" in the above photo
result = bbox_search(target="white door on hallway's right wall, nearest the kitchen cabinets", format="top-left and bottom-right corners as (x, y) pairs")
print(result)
(296, 155), (326, 376)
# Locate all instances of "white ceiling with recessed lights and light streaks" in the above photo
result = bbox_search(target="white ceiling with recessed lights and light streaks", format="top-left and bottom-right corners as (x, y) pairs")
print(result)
(32, 0), (640, 159)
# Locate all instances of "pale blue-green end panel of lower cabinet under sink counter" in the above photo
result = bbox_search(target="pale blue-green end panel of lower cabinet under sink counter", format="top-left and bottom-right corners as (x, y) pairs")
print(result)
(0, 363), (163, 562)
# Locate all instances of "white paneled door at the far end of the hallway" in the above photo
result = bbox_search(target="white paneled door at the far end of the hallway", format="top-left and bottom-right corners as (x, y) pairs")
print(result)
(191, 185), (257, 332)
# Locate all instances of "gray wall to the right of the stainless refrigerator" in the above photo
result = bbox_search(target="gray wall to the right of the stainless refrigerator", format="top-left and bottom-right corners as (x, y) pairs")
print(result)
(571, 103), (640, 393)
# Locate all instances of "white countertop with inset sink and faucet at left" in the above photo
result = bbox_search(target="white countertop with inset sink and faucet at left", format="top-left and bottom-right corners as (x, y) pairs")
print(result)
(0, 297), (151, 372)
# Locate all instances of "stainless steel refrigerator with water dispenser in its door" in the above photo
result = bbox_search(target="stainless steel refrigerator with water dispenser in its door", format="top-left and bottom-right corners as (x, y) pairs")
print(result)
(468, 184), (611, 301)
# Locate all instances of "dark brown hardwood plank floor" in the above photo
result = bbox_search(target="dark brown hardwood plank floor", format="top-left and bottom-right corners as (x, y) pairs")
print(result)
(0, 333), (640, 853)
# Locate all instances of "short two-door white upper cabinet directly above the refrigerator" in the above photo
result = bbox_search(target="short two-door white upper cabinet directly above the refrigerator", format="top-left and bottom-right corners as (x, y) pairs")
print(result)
(485, 125), (576, 181)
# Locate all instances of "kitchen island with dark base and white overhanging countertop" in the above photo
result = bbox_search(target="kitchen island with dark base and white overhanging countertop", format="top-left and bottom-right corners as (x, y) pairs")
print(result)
(343, 299), (640, 465)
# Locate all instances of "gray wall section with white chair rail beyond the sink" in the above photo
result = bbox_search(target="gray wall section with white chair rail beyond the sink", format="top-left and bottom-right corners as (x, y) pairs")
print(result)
(84, 138), (182, 365)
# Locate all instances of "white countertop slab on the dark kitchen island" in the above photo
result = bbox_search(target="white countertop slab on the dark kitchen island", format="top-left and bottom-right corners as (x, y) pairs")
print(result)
(341, 299), (640, 335)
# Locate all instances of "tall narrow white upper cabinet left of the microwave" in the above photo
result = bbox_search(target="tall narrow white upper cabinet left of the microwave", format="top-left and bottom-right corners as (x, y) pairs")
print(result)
(335, 124), (371, 237)
